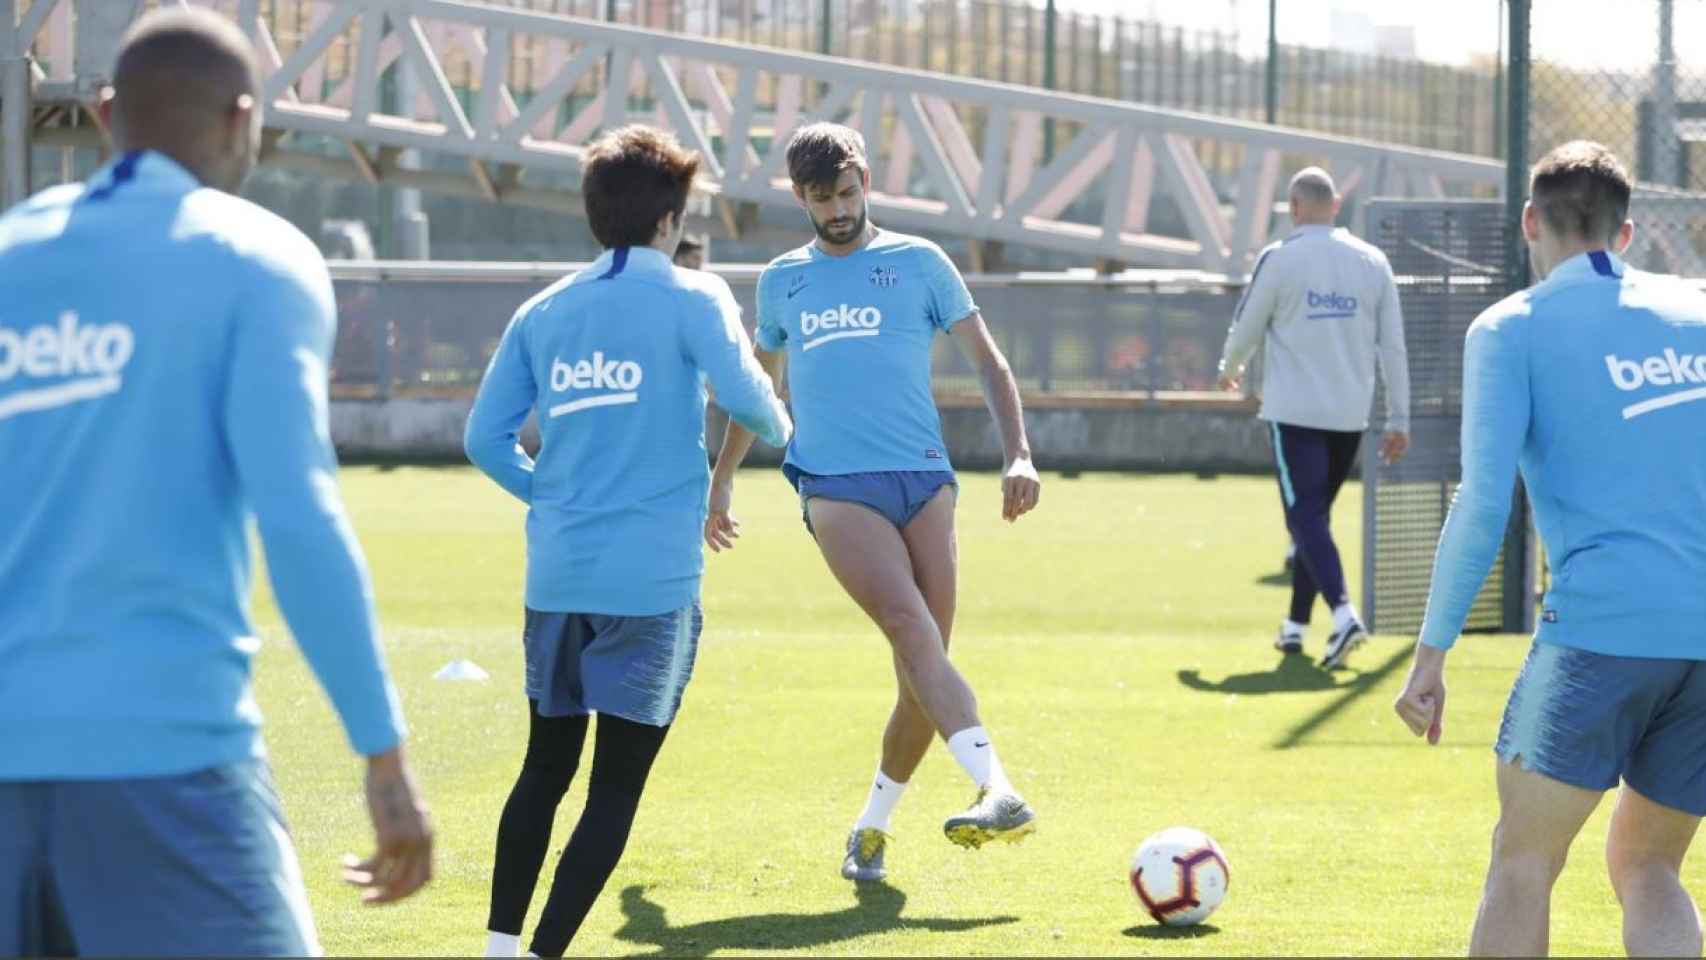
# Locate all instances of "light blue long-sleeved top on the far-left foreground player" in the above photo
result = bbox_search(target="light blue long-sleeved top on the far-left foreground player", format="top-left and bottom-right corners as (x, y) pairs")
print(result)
(0, 152), (403, 779)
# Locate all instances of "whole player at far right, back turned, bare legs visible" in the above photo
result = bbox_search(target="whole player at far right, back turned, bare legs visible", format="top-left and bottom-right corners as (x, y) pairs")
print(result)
(1396, 140), (1706, 957)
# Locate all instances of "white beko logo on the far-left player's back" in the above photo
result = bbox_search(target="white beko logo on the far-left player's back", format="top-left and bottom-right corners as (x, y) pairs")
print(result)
(0, 310), (136, 419)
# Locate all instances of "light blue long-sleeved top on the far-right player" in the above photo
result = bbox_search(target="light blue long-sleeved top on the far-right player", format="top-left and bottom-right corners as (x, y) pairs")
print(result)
(1421, 251), (1706, 660)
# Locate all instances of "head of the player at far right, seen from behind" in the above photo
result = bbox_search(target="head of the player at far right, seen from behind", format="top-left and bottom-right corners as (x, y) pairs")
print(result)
(1522, 140), (1634, 276)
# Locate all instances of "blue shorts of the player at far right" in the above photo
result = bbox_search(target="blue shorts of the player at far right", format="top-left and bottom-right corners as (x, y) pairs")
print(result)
(1496, 641), (1706, 817)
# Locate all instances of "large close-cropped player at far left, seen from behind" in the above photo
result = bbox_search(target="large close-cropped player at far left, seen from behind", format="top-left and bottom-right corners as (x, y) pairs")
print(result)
(0, 10), (432, 957)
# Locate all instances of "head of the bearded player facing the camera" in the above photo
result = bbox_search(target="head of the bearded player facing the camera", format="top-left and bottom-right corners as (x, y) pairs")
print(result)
(788, 123), (870, 247)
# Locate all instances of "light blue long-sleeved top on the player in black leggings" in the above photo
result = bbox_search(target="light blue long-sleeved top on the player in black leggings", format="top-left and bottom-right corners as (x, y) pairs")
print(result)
(464, 247), (793, 616)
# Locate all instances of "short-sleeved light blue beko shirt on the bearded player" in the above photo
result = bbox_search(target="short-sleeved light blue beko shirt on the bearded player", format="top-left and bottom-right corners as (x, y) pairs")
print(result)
(757, 230), (978, 476)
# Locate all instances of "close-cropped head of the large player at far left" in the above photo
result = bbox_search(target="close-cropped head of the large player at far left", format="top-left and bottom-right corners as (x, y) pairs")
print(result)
(99, 7), (261, 193)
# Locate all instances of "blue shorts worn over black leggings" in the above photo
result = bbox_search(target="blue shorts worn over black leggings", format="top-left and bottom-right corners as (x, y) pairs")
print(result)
(522, 600), (705, 726)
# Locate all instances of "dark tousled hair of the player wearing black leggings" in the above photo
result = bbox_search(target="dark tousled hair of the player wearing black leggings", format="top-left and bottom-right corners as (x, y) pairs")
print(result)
(580, 123), (701, 247)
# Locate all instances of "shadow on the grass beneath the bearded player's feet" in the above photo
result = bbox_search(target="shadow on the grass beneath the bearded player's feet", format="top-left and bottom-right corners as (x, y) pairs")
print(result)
(616, 883), (1018, 957)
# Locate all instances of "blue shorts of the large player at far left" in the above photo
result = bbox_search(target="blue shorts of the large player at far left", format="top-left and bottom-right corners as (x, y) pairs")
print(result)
(0, 760), (319, 957)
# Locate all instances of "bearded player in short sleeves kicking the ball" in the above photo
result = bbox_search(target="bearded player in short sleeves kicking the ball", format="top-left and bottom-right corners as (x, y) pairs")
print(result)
(705, 123), (1041, 880)
